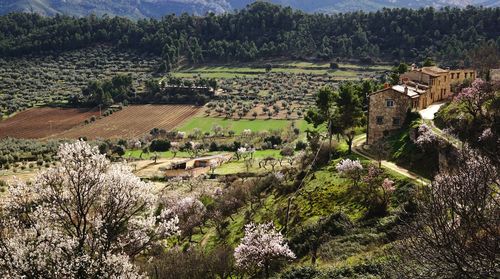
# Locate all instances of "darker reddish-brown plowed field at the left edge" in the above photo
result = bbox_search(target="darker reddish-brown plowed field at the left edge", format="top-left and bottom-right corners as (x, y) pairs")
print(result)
(0, 108), (99, 138)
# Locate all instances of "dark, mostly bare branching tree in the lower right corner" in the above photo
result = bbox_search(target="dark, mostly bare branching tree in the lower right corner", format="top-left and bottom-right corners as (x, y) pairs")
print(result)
(394, 146), (500, 278)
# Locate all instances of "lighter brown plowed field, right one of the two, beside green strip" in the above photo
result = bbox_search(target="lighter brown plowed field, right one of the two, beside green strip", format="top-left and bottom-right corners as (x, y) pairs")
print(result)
(52, 105), (200, 139)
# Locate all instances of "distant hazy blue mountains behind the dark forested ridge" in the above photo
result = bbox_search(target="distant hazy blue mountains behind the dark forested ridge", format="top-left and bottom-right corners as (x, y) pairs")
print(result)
(0, 0), (500, 18)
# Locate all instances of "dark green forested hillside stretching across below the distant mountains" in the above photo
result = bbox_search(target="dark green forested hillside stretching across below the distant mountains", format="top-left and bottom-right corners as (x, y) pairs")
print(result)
(0, 2), (500, 68)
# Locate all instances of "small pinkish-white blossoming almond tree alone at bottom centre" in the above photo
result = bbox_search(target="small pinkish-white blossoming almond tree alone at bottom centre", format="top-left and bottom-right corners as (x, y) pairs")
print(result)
(234, 223), (295, 278)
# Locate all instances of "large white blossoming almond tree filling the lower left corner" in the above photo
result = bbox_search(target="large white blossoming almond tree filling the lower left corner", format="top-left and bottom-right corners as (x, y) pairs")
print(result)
(0, 141), (178, 278)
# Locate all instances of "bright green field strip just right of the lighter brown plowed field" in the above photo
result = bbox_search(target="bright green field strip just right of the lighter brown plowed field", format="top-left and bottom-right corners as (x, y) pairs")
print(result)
(177, 117), (309, 134)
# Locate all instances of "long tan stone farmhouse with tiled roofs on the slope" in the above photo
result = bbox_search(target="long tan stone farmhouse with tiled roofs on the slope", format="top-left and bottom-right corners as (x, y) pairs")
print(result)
(366, 66), (476, 144)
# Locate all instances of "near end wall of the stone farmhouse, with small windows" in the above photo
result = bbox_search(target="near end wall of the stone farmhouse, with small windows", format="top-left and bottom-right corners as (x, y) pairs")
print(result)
(367, 88), (411, 144)
